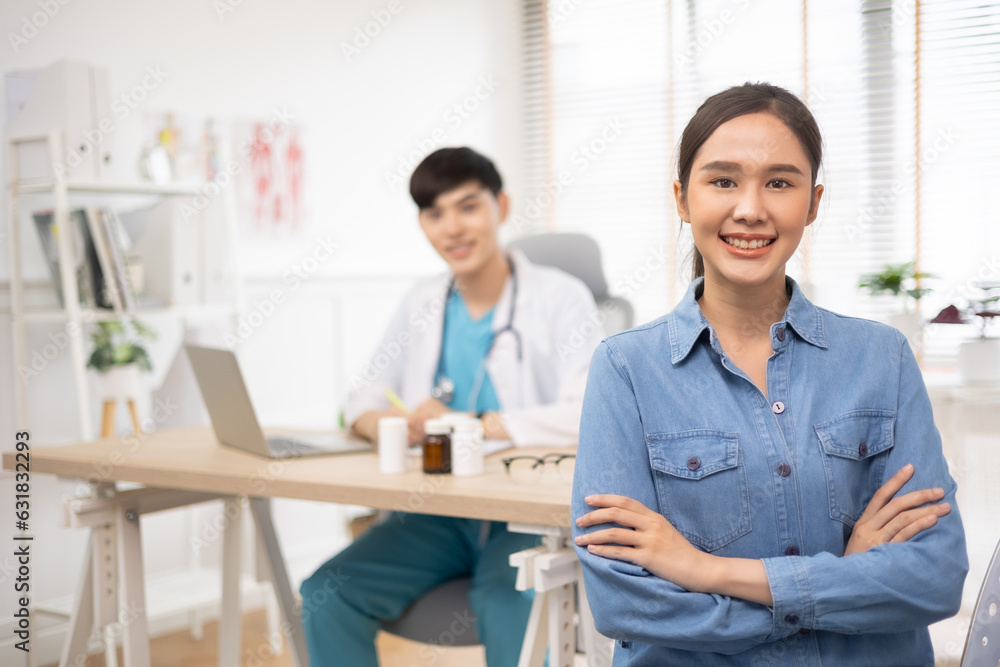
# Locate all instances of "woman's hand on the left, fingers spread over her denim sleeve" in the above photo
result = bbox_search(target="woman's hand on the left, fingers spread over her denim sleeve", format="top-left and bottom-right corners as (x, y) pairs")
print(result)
(576, 495), (711, 592)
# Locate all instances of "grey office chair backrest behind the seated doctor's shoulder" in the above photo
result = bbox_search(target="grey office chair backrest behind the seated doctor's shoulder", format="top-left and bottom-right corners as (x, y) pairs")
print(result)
(510, 232), (635, 336)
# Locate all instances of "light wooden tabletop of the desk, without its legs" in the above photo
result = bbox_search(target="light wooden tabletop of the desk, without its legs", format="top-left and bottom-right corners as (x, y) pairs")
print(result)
(15, 427), (573, 526)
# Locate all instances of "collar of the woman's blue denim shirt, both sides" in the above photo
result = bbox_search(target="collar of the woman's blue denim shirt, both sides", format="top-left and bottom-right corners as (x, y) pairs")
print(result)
(667, 276), (826, 364)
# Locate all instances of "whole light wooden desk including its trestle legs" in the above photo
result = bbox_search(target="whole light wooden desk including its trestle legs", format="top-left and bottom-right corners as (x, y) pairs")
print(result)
(3, 427), (589, 667)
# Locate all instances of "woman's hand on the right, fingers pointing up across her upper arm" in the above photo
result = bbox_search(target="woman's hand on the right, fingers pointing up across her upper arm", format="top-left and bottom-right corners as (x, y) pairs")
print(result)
(844, 463), (951, 556)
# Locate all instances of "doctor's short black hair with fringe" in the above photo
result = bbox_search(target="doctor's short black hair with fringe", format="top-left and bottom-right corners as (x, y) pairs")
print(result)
(410, 146), (503, 211)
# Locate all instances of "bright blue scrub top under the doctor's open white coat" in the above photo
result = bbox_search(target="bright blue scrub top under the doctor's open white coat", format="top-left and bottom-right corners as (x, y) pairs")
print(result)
(441, 290), (500, 413)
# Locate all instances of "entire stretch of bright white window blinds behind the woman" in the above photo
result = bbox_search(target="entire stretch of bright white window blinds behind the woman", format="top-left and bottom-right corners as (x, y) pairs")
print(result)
(515, 0), (1000, 360)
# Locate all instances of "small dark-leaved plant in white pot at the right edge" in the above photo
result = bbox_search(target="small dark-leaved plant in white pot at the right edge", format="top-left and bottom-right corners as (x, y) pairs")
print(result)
(931, 283), (1000, 387)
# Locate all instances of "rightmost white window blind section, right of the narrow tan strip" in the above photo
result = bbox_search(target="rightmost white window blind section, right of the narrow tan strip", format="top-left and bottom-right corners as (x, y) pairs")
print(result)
(911, 0), (1000, 364)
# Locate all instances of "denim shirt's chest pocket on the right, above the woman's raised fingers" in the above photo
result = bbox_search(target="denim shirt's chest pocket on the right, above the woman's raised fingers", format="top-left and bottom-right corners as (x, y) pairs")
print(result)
(813, 410), (896, 528)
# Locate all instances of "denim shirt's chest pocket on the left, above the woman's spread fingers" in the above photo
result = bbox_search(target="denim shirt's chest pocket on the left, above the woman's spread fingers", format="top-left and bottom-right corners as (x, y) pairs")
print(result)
(646, 429), (750, 551)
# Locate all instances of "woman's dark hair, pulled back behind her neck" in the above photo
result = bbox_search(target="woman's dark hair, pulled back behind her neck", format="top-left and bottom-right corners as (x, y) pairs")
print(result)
(677, 83), (823, 278)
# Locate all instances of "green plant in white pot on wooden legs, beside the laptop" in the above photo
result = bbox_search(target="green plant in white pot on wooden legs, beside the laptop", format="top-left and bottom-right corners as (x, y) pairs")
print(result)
(87, 319), (156, 438)
